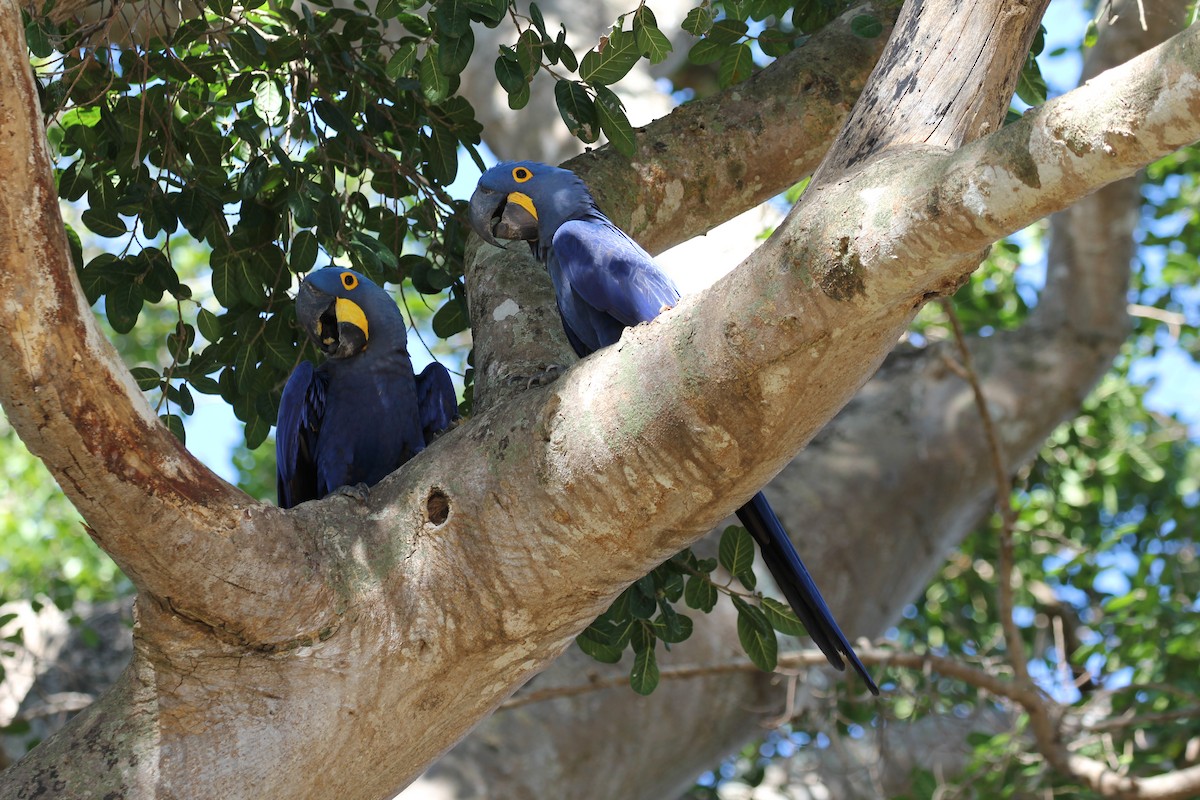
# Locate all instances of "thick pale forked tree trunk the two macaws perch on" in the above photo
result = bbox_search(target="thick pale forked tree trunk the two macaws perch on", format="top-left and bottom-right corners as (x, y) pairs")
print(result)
(0, 0), (1200, 798)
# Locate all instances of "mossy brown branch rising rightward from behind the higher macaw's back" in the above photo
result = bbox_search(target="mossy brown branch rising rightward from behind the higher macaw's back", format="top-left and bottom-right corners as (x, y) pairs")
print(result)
(564, 2), (896, 253)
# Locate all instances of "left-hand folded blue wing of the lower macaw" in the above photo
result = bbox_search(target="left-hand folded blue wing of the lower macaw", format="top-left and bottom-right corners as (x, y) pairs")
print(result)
(275, 361), (328, 509)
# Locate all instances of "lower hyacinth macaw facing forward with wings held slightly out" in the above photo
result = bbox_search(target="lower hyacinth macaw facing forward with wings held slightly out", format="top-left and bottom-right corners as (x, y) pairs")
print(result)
(275, 266), (458, 509)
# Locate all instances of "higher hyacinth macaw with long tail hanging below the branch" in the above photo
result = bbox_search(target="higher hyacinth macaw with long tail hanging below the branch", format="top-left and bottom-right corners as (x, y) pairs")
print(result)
(470, 161), (878, 694)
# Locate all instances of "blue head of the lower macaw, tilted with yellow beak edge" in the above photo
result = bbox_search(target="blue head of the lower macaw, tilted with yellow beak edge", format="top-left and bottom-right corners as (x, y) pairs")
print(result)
(296, 266), (403, 359)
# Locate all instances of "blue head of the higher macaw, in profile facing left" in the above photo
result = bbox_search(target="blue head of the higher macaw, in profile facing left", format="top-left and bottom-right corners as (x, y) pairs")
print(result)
(470, 161), (596, 245)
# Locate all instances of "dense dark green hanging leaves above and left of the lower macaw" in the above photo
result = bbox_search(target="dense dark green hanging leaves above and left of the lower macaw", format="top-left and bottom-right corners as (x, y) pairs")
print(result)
(30, 2), (482, 449)
